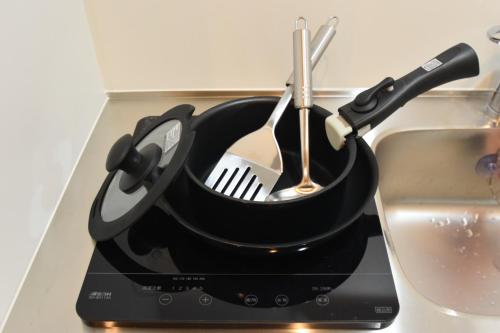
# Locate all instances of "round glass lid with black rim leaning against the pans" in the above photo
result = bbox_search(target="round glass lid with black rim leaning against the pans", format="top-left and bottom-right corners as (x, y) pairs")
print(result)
(89, 104), (195, 241)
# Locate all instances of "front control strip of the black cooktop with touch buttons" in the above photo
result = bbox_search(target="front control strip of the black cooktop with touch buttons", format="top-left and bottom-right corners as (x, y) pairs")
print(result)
(78, 274), (399, 324)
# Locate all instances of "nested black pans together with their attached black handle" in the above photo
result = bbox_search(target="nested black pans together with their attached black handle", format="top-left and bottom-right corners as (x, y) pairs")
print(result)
(159, 44), (479, 254)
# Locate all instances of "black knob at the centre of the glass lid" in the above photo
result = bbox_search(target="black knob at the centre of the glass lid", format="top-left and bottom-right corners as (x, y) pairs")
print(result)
(106, 134), (162, 193)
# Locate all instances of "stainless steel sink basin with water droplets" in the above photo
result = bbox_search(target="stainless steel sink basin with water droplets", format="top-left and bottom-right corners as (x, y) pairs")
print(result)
(376, 128), (500, 316)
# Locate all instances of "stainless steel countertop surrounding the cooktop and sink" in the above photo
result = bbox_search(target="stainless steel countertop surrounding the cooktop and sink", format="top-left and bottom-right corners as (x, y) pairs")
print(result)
(3, 94), (500, 333)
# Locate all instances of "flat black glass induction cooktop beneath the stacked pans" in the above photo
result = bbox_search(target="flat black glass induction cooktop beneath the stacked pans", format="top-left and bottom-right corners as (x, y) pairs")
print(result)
(77, 201), (399, 328)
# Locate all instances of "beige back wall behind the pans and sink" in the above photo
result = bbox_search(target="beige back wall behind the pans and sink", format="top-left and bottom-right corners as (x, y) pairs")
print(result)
(86, 0), (500, 90)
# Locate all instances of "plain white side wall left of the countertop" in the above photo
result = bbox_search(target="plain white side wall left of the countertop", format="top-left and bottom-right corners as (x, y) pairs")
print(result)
(0, 0), (105, 327)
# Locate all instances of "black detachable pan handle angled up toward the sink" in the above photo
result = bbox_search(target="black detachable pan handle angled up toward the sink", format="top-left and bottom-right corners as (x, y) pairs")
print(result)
(339, 43), (479, 132)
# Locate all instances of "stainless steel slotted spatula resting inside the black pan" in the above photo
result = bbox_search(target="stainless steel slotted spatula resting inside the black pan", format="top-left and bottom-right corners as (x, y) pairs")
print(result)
(205, 17), (338, 201)
